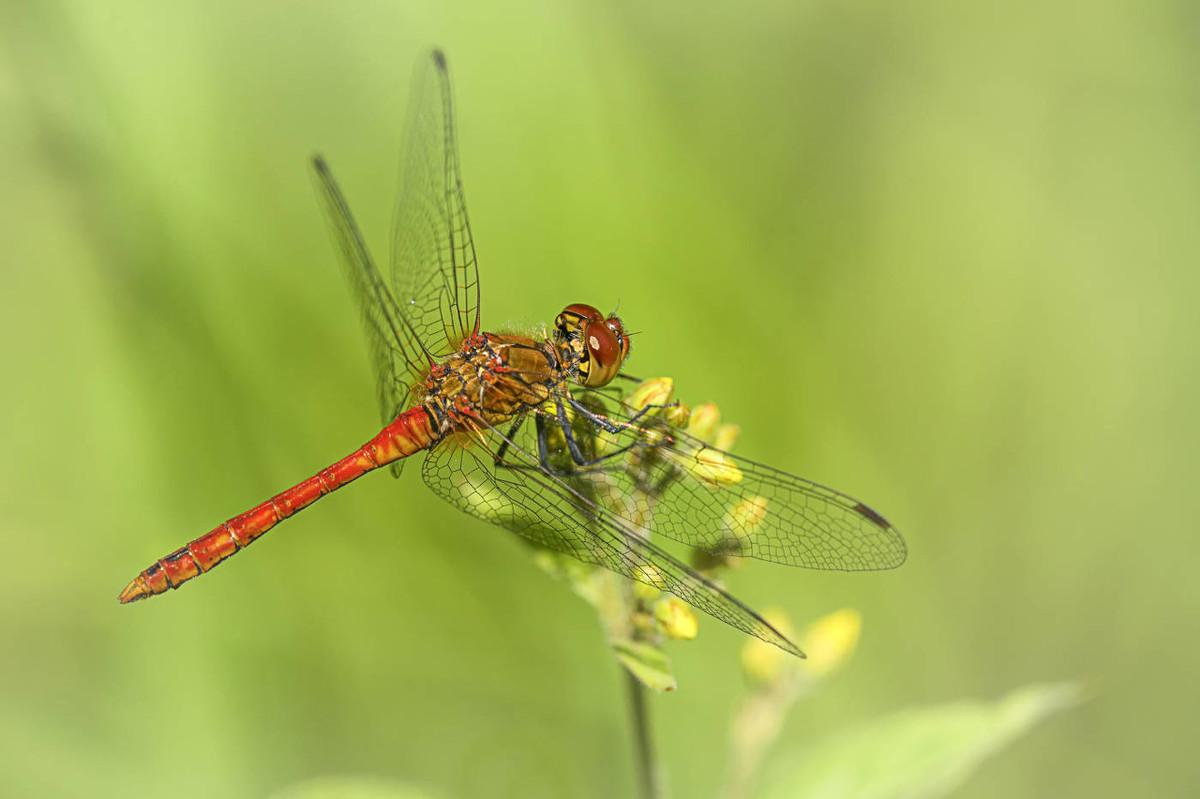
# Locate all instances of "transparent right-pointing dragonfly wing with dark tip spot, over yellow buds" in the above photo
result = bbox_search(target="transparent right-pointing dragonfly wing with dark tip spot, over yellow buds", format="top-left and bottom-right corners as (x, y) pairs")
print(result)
(554, 391), (907, 571)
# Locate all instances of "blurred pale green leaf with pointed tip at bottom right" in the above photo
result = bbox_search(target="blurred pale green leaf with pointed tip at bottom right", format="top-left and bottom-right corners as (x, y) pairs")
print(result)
(758, 684), (1082, 799)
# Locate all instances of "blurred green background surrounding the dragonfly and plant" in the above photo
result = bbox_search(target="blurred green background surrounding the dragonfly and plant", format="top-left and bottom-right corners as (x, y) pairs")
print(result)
(0, 0), (1200, 798)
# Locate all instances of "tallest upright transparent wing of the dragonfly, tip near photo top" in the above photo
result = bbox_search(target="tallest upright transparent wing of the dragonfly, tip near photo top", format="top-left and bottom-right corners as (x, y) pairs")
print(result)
(391, 50), (479, 357)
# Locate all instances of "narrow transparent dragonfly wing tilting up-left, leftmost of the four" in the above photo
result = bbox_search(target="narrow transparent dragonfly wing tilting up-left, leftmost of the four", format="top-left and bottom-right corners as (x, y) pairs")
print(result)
(312, 156), (430, 436)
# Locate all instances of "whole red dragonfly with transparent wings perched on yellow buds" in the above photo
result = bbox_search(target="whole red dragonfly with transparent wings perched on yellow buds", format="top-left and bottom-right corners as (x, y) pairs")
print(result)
(119, 50), (906, 656)
